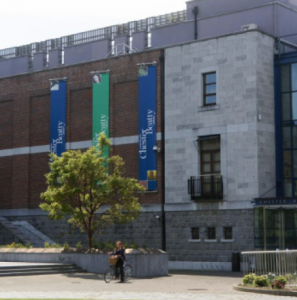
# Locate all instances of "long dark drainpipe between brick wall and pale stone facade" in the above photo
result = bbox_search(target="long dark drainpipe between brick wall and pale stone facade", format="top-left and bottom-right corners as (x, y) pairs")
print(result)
(159, 50), (166, 251)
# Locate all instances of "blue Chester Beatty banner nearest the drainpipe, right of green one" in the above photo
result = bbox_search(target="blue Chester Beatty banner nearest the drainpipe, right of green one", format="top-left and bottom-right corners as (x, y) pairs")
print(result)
(138, 66), (157, 191)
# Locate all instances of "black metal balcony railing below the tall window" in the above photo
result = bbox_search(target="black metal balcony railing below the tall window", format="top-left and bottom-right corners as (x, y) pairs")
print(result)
(188, 175), (223, 200)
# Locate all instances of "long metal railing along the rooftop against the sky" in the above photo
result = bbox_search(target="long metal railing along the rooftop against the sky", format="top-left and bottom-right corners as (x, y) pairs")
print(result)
(0, 10), (187, 59)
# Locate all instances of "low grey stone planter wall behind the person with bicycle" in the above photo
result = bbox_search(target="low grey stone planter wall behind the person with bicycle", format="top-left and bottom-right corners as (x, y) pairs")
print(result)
(0, 248), (168, 278)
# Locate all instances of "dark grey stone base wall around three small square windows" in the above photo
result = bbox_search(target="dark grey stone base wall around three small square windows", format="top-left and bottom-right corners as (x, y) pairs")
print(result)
(166, 209), (254, 263)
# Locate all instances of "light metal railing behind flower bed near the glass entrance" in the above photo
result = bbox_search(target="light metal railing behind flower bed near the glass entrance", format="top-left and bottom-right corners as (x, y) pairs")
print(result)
(241, 250), (297, 276)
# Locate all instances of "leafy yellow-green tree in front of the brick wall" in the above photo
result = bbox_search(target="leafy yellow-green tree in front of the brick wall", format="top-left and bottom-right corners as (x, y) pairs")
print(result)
(40, 133), (143, 248)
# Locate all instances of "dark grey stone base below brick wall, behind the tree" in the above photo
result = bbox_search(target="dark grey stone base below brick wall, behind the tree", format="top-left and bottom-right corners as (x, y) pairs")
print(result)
(0, 212), (162, 249)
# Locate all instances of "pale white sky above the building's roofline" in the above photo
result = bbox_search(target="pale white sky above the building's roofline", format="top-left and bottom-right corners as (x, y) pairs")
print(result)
(0, 0), (186, 49)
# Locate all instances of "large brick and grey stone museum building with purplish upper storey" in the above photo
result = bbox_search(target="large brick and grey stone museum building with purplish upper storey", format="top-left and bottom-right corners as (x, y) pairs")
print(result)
(0, 0), (297, 270)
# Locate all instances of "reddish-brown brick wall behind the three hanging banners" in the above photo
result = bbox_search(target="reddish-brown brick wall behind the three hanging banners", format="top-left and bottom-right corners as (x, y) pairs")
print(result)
(0, 51), (162, 209)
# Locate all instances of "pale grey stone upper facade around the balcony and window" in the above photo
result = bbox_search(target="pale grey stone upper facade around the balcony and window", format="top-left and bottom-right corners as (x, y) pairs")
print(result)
(165, 31), (275, 209)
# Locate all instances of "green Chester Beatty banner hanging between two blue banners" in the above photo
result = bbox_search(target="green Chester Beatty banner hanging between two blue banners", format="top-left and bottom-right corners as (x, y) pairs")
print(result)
(93, 72), (109, 156)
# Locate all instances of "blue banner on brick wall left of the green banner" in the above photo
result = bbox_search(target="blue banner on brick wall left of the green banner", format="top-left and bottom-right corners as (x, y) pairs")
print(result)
(50, 80), (67, 156)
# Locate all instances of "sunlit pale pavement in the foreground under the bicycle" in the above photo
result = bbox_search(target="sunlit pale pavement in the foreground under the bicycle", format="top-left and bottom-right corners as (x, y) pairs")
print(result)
(0, 263), (295, 300)
